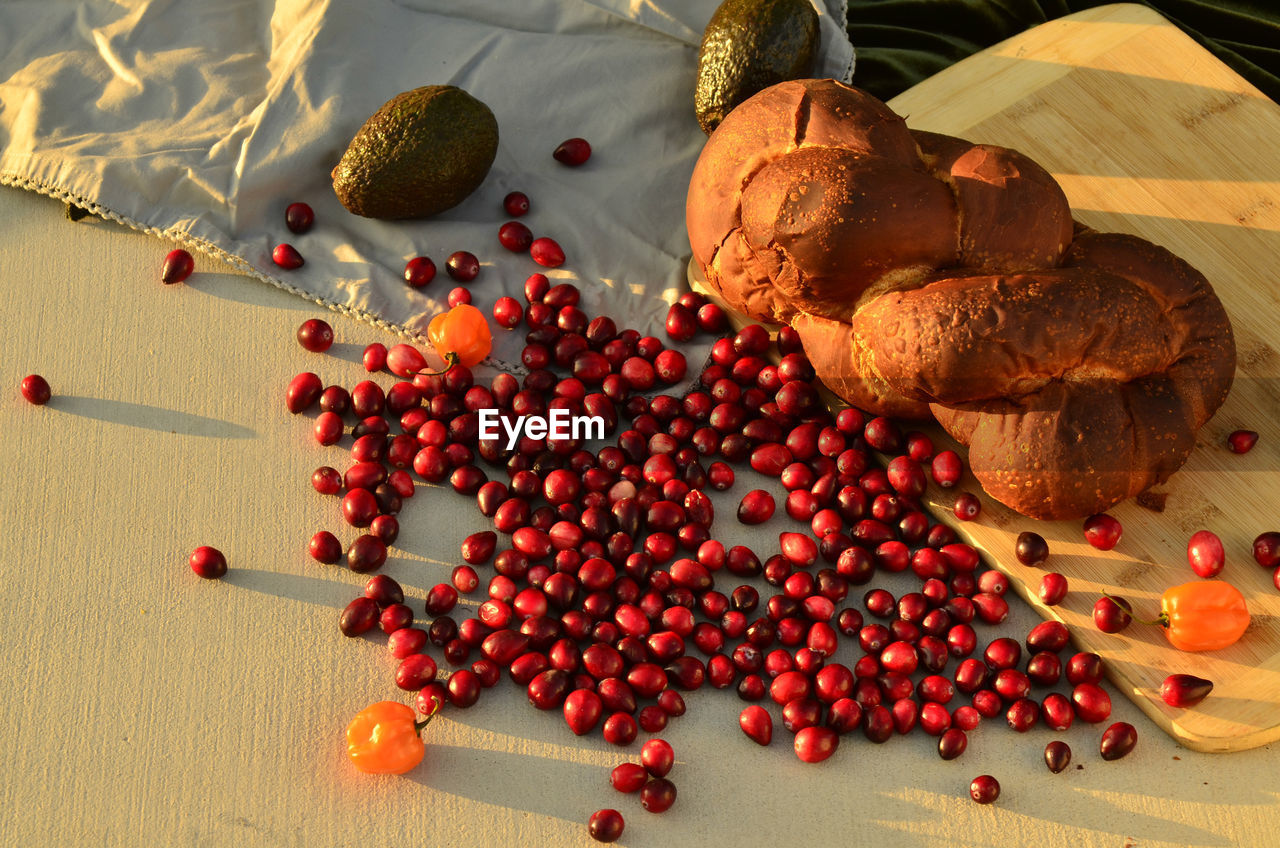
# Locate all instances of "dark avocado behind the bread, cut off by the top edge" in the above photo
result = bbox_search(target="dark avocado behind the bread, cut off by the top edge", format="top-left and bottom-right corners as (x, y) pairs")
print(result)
(694, 0), (818, 136)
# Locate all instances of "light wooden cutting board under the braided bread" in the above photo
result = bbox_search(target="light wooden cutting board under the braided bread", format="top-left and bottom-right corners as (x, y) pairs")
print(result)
(691, 5), (1280, 751)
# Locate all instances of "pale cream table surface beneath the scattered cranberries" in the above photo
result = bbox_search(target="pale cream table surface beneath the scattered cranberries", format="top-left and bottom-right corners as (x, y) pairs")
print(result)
(0, 188), (1280, 847)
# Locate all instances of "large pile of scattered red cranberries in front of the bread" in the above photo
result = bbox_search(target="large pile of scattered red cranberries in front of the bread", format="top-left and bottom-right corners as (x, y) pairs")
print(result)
(280, 267), (1135, 834)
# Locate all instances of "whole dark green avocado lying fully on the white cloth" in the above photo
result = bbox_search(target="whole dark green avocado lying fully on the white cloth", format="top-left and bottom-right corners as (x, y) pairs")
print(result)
(332, 86), (498, 218)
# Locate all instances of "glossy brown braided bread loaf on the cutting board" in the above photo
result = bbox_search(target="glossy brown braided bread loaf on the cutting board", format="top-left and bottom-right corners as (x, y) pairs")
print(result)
(686, 79), (1235, 519)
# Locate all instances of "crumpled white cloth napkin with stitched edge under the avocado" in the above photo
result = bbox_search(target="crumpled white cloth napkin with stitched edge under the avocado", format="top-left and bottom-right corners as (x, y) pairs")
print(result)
(0, 0), (854, 361)
